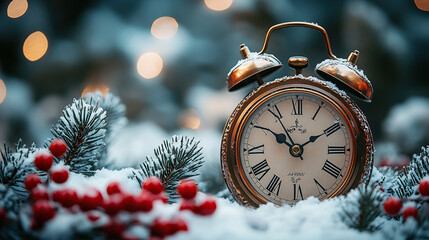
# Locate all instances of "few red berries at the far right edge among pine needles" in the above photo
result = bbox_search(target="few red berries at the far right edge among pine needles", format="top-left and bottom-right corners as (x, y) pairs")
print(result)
(383, 179), (429, 221)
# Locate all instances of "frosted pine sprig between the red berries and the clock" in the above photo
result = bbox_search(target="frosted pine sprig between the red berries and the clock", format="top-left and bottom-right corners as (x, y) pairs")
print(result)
(133, 136), (203, 201)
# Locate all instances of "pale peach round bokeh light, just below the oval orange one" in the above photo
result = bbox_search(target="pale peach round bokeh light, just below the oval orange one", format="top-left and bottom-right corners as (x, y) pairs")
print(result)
(137, 52), (164, 79)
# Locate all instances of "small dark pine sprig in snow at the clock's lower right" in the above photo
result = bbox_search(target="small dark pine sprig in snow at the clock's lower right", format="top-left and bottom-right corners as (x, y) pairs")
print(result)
(340, 184), (383, 232)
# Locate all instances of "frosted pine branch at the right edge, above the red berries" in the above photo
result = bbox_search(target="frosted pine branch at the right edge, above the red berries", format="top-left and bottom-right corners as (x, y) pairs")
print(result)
(387, 146), (429, 198)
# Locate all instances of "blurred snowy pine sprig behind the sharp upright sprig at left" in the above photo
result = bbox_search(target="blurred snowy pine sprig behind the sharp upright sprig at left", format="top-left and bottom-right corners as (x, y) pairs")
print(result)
(84, 90), (127, 168)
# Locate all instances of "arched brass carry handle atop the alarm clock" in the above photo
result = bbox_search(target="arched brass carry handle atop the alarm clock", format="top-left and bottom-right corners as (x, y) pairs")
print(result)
(258, 22), (338, 59)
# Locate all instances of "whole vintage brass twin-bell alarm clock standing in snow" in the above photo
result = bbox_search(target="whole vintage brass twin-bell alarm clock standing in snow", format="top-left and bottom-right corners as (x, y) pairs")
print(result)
(221, 22), (374, 207)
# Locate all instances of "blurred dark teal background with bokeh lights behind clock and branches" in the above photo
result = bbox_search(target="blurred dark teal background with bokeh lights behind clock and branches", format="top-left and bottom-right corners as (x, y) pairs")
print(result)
(0, 0), (429, 191)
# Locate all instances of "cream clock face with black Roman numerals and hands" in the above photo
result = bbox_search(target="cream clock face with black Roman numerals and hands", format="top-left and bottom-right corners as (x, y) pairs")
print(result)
(239, 92), (354, 205)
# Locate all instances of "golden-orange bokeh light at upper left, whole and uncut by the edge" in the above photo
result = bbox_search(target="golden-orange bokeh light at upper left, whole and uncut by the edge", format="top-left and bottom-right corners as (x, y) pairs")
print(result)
(22, 31), (48, 62)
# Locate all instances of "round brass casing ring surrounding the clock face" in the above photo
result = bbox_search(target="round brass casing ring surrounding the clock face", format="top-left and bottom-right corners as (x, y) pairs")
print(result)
(221, 75), (374, 207)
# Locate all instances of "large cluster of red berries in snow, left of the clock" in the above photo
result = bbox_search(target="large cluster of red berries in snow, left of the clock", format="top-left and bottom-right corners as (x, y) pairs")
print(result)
(24, 141), (216, 239)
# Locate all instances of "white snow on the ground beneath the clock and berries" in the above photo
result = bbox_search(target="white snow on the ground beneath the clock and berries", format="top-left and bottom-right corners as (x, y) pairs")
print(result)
(31, 168), (415, 240)
